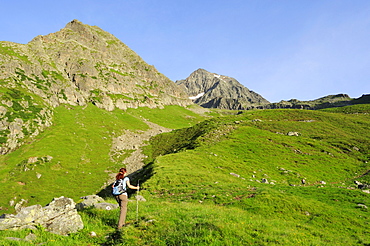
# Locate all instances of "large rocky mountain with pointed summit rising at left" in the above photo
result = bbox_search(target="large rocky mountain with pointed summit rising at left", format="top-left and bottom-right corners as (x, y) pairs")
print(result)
(0, 20), (192, 154)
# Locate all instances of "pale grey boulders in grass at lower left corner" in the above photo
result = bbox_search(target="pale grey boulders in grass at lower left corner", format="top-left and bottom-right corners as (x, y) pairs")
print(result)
(0, 196), (84, 235)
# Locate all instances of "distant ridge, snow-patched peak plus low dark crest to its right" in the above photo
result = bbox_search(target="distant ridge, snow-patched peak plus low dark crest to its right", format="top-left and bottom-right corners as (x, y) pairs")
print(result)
(175, 68), (370, 110)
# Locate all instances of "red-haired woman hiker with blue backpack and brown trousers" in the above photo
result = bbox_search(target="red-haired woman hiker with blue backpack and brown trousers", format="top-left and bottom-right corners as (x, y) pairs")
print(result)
(114, 168), (139, 229)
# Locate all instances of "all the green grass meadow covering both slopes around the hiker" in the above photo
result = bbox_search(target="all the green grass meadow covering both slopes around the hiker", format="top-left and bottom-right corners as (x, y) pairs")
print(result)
(0, 104), (370, 245)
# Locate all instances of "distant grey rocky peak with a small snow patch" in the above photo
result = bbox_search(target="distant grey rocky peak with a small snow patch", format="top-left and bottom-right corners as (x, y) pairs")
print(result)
(176, 69), (269, 110)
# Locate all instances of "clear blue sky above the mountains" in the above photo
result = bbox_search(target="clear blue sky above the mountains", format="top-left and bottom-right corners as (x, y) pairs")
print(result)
(0, 0), (370, 102)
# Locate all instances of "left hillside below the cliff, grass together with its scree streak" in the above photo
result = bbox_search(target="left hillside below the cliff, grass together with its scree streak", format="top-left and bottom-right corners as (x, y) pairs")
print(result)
(0, 104), (208, 213)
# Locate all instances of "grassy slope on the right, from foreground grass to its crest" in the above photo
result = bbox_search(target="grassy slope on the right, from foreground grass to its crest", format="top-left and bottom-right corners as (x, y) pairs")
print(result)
(3, 106), (370, 245)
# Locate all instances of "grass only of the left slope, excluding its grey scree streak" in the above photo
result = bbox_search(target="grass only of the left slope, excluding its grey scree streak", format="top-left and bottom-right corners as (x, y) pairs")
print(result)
(0, 105), (207, 212)
